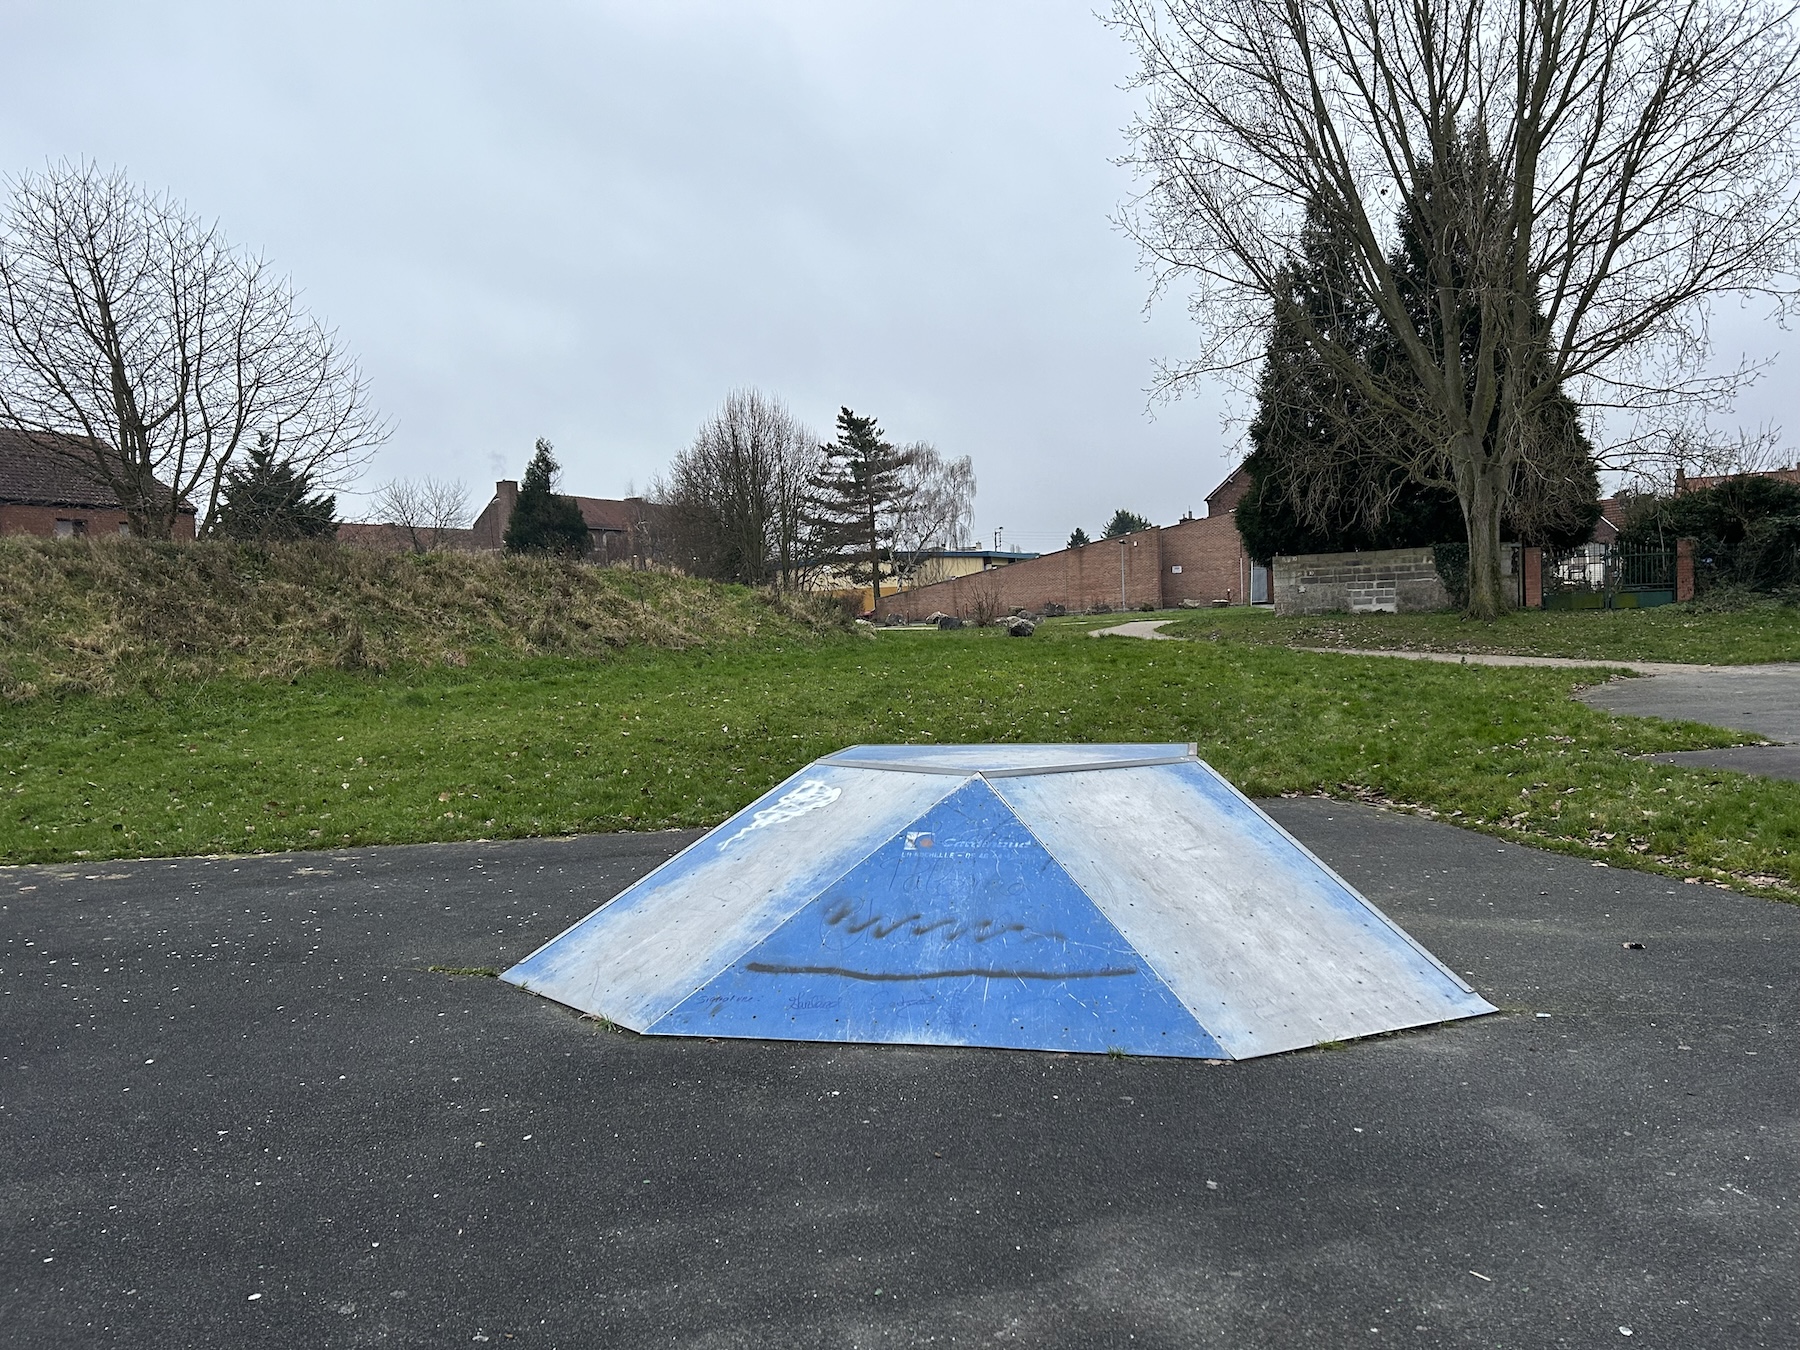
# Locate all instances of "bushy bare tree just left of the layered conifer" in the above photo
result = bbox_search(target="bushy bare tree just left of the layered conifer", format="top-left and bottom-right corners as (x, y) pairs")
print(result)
(650, 389), (819, 589)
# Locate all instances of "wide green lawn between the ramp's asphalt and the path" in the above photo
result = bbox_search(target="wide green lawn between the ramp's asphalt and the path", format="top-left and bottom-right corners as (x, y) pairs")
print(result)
(0, 616), (1800, 898)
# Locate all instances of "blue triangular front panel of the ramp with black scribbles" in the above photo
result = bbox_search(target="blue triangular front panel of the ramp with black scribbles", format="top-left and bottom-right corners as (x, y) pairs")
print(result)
(648, 779), (1224, 1058)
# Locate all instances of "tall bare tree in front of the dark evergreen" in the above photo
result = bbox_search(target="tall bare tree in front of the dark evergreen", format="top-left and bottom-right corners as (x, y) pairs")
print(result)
(1112, 0), (1800, 616)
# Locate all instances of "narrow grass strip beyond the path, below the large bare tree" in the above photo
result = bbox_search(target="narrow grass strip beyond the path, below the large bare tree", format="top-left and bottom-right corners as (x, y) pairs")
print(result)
(1152, 601), (1800, 666)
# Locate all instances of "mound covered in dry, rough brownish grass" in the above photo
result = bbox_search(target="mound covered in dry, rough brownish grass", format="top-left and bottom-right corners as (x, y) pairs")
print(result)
(0, 538), (842, 702)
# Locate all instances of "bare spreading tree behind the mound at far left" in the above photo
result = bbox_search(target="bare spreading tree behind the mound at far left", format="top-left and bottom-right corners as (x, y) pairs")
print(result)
(0, 164), (387, 538)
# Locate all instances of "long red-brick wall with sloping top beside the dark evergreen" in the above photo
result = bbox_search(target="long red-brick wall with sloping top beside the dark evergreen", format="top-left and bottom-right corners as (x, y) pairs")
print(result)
(878, 464), (1269, 619)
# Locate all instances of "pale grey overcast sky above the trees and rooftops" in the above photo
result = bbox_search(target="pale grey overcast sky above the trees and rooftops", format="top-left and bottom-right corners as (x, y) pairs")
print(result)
(0, 0), (1800, 549)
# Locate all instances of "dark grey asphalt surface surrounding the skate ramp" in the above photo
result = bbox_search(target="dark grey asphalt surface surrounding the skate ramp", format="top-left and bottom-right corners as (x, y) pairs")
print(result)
(0, 810), (1800, 1350)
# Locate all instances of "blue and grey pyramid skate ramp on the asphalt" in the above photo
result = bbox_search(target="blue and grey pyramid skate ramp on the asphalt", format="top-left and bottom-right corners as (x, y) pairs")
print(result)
(504, 745), (1494, 1058)
